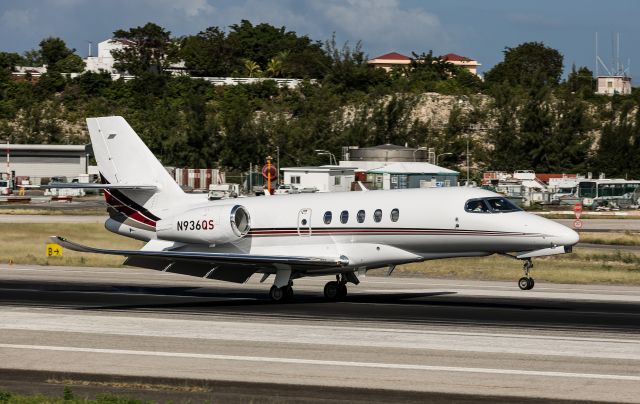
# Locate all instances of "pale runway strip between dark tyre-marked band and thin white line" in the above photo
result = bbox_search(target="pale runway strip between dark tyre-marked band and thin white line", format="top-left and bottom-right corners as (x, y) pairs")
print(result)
(0, 311), (640, 361)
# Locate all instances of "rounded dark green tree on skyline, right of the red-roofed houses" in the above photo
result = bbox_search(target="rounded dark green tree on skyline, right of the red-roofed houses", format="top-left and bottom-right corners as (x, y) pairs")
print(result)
(485, 42), (563, 88)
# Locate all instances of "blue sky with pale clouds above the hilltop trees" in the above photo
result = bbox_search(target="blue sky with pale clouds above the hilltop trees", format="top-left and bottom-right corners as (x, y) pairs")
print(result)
(0, 0), (640, 75)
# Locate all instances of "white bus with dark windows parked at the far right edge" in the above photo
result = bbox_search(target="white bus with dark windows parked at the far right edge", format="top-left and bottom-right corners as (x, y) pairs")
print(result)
(578, 179), (640, 208)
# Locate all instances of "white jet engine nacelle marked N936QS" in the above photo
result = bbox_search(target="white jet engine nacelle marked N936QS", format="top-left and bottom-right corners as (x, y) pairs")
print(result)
(156, 205), (251, 245)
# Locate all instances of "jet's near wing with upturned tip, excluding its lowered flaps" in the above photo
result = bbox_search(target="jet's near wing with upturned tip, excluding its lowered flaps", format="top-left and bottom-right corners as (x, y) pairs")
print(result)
(49, 236), (349, 268)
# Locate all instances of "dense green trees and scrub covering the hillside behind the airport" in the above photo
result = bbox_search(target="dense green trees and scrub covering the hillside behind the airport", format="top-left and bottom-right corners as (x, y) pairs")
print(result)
(0, 21), (640, 178)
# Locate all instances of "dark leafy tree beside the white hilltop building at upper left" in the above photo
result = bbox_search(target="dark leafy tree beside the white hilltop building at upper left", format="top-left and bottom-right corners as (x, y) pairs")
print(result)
(111, 22), (178, 76)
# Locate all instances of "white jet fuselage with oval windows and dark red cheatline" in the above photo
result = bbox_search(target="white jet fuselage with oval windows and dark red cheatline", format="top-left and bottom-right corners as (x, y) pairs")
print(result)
(110, 187), (578, 267)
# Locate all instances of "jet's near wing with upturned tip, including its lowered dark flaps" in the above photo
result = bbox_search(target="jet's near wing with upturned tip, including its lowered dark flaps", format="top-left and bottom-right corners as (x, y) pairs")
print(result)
(49, 236), (349, 283)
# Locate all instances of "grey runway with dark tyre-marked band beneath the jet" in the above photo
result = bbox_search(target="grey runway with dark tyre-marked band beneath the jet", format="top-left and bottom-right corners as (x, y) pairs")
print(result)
(0, 266), (640, 402)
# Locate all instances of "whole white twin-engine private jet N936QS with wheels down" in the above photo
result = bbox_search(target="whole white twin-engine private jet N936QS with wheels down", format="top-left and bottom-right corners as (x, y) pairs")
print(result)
(51, 117), (578, 301)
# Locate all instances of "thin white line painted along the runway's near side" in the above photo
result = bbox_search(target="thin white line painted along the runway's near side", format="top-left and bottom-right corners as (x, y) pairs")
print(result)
(0, 344), (640, 382)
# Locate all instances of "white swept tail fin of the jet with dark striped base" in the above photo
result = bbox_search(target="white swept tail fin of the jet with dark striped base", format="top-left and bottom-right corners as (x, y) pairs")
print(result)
(87, 116), (184, 219)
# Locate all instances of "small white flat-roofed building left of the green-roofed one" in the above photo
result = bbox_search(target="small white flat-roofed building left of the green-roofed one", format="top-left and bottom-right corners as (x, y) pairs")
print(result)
(280, 166), (355, 192)
